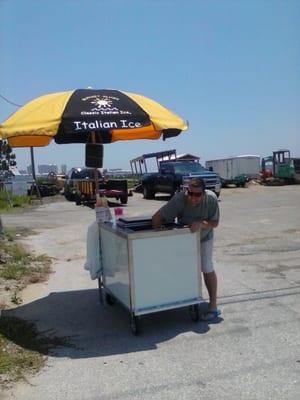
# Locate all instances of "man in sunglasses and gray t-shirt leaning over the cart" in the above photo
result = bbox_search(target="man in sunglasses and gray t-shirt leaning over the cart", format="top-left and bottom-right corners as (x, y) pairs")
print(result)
(152, 178), (221, 321)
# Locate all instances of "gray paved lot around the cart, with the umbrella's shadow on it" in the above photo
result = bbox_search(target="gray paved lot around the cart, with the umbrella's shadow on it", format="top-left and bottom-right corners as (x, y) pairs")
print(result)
(2, 184), (300, 400)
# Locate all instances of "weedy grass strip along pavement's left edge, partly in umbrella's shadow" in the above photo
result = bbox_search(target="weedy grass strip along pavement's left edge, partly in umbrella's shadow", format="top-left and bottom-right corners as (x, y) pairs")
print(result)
(0, 230), (74, 386)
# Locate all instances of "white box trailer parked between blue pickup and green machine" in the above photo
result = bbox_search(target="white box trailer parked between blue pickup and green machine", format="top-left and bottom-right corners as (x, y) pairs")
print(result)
(205, 155), (260, 186)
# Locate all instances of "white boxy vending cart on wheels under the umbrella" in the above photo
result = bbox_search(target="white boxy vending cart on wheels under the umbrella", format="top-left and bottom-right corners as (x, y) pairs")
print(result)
(99, 217), (202, 334)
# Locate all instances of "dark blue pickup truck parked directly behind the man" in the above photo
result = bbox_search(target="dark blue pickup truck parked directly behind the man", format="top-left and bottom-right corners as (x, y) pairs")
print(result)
(141, 160), (221, 199)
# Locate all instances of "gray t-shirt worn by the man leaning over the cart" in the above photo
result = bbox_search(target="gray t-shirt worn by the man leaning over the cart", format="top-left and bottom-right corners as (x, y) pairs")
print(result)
(160, 190), (220, 242)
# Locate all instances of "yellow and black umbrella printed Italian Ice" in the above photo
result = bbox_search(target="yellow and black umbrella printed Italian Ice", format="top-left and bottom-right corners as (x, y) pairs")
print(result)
(0, 89), (187, 147)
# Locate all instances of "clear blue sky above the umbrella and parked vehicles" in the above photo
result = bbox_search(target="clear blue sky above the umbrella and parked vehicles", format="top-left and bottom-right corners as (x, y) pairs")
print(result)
(0, 0), (300, 169)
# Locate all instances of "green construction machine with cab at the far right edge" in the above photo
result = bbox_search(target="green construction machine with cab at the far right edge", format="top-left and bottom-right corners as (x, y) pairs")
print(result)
(261, 149), (300, 184)
